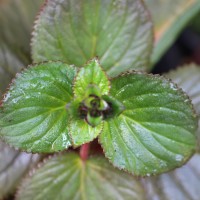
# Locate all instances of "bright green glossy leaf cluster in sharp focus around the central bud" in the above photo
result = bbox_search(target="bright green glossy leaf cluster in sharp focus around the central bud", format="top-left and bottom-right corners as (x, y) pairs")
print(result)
(0, 59), (197, 176)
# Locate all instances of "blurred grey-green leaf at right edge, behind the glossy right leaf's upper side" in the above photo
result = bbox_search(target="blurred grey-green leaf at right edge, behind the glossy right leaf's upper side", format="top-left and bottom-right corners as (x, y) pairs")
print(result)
(166, 64), (200, 151)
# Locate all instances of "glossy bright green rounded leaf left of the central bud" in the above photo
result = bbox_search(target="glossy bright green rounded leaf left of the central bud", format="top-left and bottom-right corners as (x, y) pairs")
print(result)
(0, 62), (76, 152)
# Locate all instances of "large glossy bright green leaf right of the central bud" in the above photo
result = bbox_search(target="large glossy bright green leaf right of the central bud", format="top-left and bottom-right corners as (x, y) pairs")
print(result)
(100, 73), (197, 176)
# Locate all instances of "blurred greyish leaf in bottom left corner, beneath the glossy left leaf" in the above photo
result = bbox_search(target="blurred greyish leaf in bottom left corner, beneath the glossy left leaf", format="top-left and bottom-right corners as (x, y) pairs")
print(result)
(0, 141), (39, 199)
